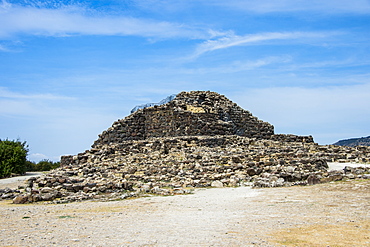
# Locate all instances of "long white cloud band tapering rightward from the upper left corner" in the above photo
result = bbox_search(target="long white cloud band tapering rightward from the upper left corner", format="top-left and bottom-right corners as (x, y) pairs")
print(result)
(0, 1), (210, 38)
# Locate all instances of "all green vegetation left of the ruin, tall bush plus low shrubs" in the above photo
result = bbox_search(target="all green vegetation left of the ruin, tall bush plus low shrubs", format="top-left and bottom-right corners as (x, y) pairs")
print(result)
(0, 139), (60, 178)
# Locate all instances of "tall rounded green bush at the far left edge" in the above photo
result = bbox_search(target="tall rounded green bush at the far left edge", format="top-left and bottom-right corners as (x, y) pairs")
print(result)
(0, 139), (28, 178)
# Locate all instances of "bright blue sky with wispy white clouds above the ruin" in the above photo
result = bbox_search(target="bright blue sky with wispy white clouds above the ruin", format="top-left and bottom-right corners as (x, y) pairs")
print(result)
(0, 0), (370, 161)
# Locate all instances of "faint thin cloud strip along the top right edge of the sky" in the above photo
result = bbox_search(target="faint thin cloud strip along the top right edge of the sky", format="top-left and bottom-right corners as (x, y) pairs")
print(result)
(210, 0), (370, 14)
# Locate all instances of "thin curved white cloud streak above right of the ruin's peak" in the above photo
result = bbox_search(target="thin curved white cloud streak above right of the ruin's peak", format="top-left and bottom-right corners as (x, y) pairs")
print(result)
(191, 32), (333, 58)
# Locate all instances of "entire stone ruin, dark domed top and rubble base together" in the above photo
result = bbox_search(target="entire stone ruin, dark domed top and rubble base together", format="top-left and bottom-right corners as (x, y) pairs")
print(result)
(6, 91), (370, 203)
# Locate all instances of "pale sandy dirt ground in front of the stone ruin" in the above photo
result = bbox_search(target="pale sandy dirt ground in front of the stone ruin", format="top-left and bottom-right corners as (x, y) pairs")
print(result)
(0, 180), (370, 247)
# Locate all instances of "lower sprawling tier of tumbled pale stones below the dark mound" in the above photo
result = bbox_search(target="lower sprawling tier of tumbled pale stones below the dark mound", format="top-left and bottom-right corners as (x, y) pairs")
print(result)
(13, 135), (364, 202)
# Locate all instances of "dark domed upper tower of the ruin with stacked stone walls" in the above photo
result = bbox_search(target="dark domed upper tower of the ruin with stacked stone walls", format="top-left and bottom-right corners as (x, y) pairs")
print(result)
(93, 92), (274, 147)
